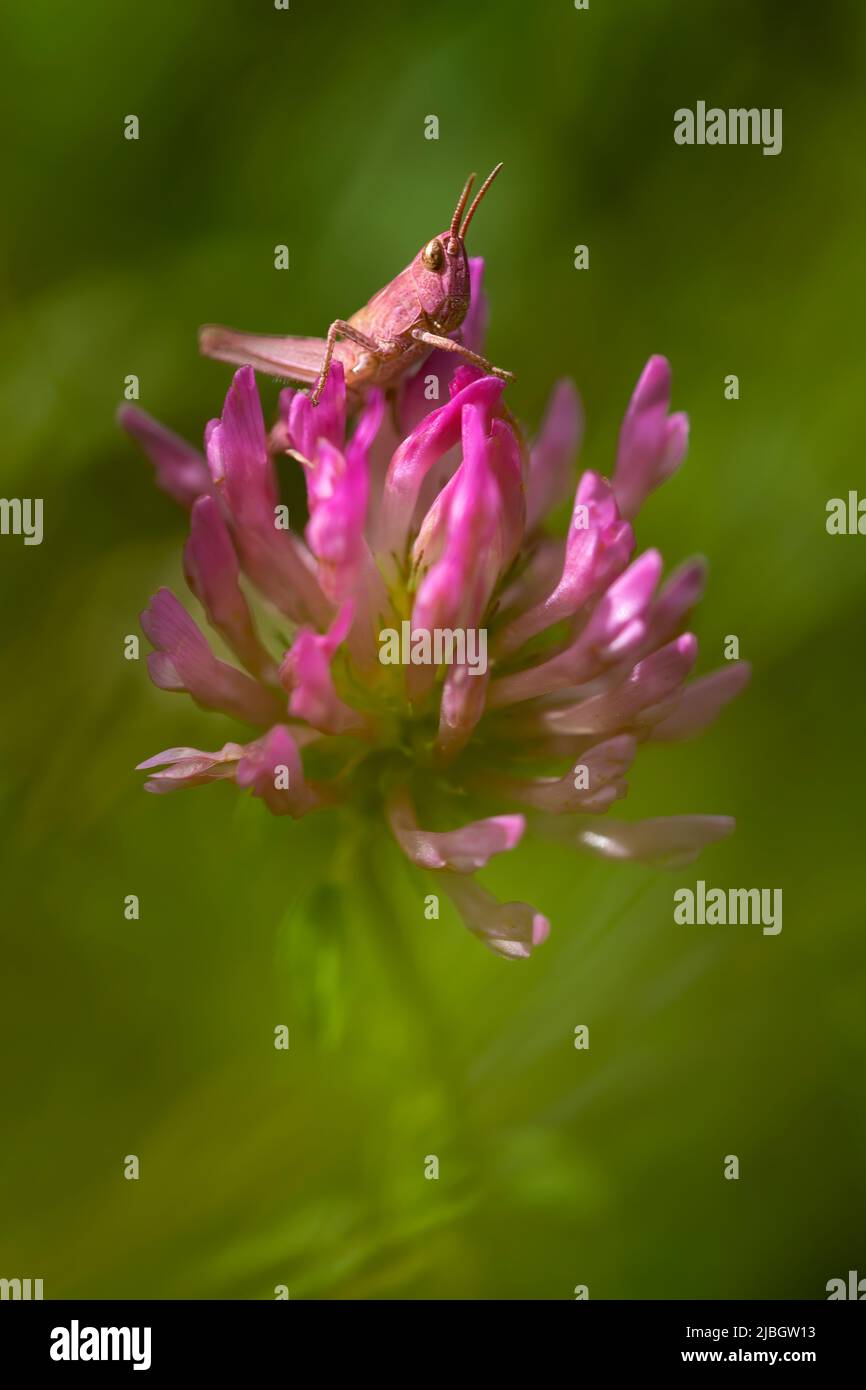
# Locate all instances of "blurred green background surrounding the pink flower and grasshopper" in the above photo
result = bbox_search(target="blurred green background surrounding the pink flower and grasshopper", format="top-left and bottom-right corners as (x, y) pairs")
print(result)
(0, 0), (866, 1300)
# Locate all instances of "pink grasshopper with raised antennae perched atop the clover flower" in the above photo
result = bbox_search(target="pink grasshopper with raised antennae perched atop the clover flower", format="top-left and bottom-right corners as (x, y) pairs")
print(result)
(199, 164), (514, 406)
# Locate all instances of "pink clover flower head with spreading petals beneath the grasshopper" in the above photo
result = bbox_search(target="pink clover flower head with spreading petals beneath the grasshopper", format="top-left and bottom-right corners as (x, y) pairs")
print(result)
(120, 259), (749, 958)
